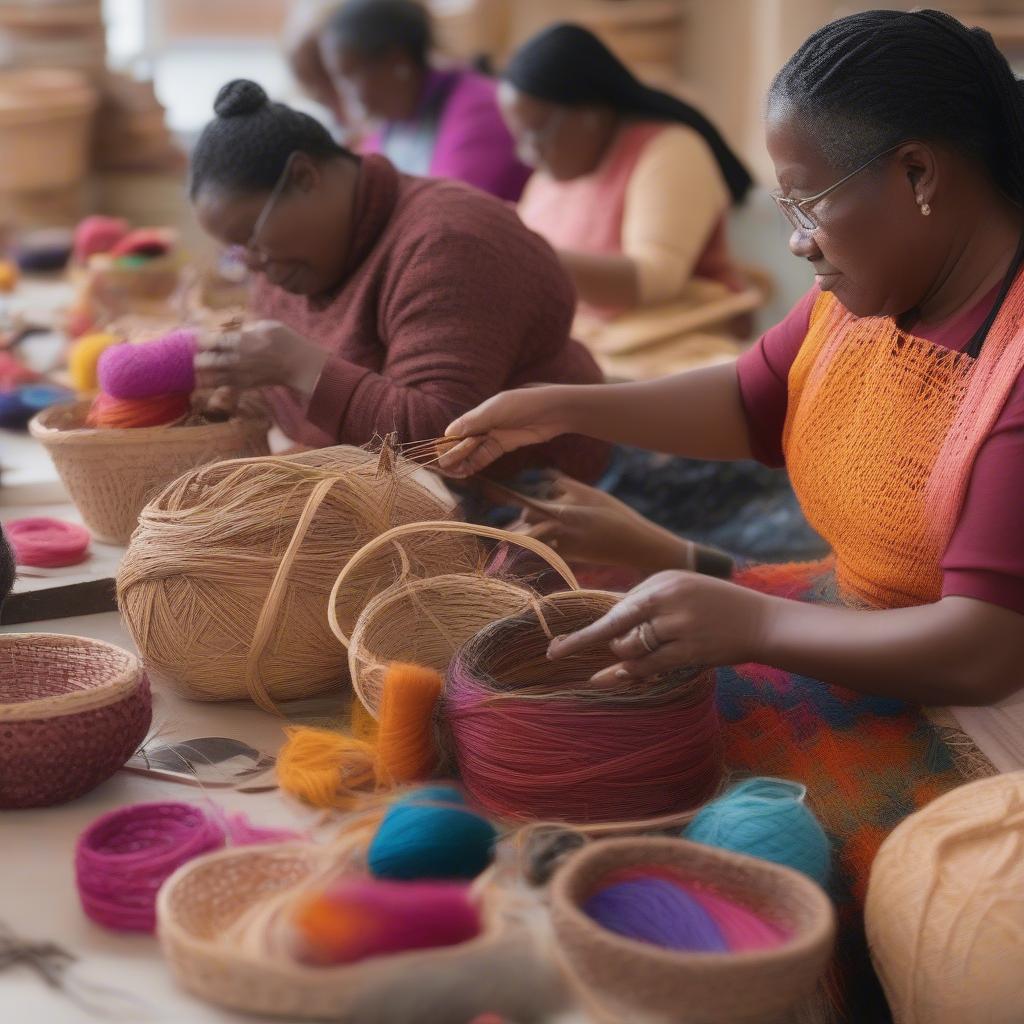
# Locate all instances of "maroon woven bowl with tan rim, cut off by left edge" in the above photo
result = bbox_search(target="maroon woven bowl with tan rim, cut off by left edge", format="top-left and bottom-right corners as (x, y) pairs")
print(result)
(0, 633), (152, 809)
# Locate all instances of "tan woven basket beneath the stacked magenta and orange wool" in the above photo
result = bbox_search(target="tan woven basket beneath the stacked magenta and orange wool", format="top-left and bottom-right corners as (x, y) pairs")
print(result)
(29, 401), (269, 544)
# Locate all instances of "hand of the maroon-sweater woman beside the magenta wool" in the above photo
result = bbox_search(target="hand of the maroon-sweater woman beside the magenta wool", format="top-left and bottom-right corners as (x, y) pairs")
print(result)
(196, 321), (327, 401)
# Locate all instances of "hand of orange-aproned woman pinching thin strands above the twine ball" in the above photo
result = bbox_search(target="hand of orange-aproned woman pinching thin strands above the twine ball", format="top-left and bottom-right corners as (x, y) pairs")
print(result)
(437, 384), (573, 477)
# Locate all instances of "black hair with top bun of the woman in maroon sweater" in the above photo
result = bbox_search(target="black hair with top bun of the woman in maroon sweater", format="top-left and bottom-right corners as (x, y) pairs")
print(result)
(188, 78), (356, 199)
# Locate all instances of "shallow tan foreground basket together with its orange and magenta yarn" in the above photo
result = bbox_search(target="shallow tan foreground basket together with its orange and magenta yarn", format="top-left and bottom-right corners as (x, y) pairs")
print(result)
(157, 844), (565, 1024)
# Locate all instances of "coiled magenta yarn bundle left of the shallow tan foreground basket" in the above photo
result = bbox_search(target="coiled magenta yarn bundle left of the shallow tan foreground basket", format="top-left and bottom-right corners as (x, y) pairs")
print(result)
(75, 803), (225, 932)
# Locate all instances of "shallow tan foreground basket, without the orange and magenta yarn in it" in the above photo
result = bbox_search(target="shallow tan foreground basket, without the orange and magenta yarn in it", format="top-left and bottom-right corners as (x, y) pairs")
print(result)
(157, 844), (565, 1024)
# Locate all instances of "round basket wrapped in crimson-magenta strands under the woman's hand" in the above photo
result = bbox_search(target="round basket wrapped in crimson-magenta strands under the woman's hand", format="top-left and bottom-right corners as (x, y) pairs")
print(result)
(439, 591), (722, 823)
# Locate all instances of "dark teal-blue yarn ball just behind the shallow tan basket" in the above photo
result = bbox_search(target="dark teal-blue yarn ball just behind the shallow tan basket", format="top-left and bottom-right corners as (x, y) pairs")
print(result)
(368, 786), (498, 882)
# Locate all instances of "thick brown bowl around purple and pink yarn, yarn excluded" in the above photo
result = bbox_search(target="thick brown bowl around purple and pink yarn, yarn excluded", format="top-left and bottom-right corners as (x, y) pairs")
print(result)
(550, 837), (836, 1024)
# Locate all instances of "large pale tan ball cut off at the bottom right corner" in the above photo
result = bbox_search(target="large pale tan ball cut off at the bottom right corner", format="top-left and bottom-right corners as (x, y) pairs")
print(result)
(865, 771), (1024, 1024)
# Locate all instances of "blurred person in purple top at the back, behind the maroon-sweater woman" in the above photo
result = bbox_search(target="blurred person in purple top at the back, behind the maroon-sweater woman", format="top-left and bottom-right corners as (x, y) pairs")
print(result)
(319, 0), (530, 202)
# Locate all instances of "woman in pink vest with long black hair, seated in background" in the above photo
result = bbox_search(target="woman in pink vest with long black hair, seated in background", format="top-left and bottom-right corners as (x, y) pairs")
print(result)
(499, 25), (751, 315)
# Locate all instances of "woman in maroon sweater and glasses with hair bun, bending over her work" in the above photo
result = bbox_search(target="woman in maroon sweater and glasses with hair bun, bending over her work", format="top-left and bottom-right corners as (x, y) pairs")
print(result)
(190, 80), (607, 479)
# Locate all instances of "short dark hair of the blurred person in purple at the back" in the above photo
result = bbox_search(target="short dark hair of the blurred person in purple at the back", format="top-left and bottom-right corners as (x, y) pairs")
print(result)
(325, 0), (434, 67)
